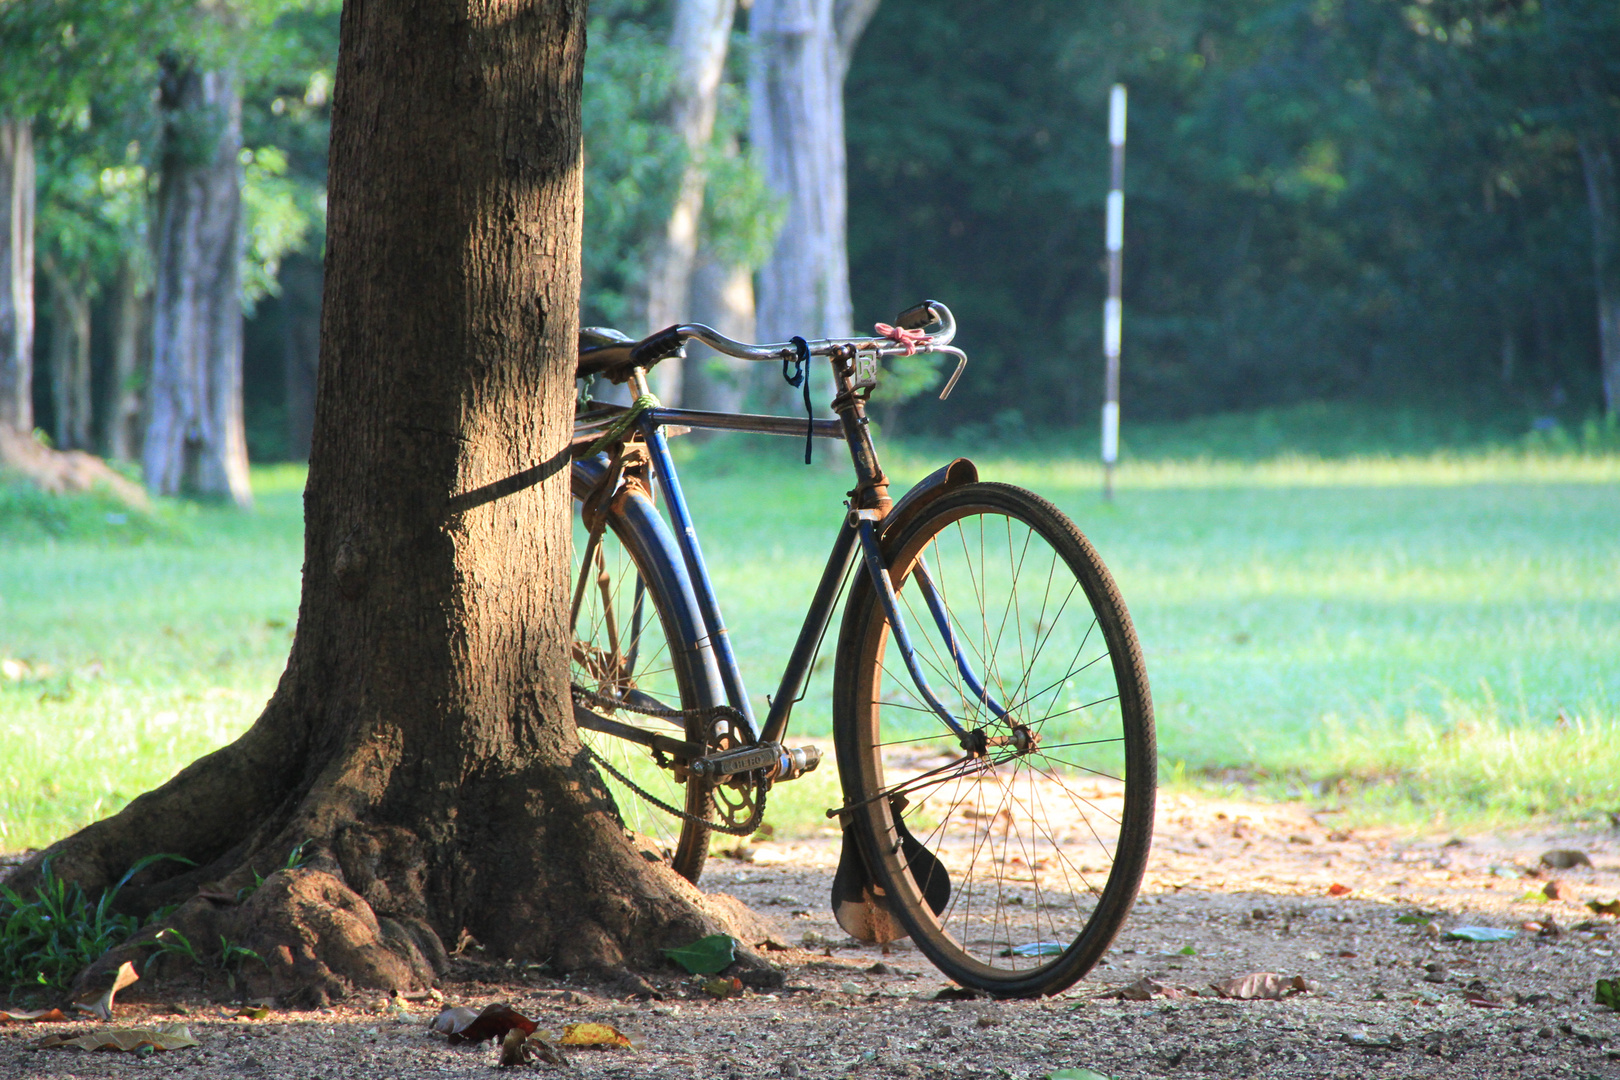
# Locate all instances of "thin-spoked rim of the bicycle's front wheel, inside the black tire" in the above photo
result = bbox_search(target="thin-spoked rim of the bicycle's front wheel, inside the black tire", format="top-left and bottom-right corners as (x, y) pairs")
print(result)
(857, 504), (1152, 989)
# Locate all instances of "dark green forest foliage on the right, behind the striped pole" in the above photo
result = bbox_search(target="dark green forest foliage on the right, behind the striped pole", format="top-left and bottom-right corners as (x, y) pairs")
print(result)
(847, 0), (1620, 437)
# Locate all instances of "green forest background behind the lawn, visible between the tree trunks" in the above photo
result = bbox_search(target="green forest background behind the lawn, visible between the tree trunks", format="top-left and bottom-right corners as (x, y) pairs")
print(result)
(5, 0), (1620, 461)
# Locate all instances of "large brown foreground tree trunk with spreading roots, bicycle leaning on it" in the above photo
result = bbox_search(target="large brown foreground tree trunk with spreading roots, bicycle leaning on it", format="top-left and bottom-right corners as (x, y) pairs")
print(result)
(8, 0), (771, 1006)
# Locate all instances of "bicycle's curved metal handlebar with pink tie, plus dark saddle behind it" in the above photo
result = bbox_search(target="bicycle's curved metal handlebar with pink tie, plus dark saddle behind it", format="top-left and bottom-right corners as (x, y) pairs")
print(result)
(577, 300), (967, 400)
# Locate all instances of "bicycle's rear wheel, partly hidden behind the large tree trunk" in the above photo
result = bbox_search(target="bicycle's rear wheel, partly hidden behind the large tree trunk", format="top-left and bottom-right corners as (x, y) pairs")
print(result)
(569, 458), (726, 884)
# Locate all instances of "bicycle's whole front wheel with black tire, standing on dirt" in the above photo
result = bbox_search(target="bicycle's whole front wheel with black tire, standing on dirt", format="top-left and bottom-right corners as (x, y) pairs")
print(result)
(833, 483), (1157, 997)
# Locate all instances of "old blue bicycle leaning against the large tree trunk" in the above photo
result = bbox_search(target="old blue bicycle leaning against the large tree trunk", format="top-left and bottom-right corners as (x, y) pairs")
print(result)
(570, 301), (1157, 997)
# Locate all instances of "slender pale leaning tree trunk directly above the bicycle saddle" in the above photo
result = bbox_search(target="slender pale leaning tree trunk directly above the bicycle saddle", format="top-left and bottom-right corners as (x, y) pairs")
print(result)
(646, 0), (737, 406)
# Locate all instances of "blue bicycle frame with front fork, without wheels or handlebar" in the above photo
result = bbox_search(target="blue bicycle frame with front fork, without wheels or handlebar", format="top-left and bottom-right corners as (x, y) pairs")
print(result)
(612, 348), (1006, 767)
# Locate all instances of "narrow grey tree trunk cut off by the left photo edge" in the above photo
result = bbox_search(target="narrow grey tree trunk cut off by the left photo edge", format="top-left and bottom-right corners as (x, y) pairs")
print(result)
(0, 117), (34, 432)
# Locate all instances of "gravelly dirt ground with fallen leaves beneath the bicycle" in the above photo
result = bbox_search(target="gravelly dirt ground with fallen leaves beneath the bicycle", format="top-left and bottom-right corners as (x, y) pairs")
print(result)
(0, 795), (1620, 1080)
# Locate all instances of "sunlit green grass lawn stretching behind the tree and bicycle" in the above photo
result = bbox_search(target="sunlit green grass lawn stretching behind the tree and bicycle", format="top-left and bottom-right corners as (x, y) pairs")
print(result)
(0, 420), (1620, 850)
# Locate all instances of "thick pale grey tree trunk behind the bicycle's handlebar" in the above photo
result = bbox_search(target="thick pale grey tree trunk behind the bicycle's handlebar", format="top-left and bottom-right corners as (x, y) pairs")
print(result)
(748, 0), (876, 405)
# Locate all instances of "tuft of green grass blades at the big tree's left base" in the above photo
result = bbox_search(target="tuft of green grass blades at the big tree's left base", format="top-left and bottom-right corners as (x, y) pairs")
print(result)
(0, 855), (190, 996)
